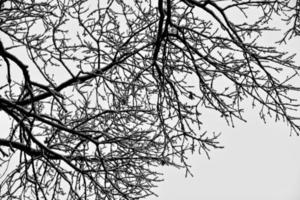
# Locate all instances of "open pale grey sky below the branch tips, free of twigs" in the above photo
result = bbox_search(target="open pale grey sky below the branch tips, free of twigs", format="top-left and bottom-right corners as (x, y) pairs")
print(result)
(147, 104), (300, 200)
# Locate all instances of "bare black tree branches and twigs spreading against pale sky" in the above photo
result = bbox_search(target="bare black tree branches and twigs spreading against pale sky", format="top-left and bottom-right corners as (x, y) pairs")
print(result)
(0, 0), (300, 200)
